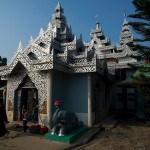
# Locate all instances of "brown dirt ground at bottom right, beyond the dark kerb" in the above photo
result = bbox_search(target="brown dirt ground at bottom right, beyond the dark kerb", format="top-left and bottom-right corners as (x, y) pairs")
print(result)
(74, 120), (150, 150)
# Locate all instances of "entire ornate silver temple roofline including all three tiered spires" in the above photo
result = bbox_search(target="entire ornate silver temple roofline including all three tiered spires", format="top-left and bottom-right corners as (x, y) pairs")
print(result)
(0, 2), (142, 76)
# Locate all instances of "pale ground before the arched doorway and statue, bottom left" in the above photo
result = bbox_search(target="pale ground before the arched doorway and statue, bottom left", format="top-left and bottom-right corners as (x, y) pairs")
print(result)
(0, 131), (67, 150)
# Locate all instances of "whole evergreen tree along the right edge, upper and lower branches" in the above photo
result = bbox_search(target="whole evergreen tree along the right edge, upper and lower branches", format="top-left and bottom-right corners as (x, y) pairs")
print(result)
(128, 0), (150, 99)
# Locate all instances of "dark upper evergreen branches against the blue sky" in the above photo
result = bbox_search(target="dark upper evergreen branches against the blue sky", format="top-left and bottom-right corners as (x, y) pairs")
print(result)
(129, 0), (150, 56)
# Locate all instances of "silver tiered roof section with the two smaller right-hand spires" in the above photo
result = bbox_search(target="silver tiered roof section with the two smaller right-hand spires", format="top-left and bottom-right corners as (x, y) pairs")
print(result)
(86, 14), (140, 74)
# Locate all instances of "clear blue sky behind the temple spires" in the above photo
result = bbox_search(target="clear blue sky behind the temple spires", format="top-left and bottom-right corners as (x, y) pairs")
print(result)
(0, 0), (134, 63)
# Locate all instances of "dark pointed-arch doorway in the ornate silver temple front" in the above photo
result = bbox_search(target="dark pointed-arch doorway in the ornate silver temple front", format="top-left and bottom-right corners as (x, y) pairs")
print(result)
(14, 76), (38, 122)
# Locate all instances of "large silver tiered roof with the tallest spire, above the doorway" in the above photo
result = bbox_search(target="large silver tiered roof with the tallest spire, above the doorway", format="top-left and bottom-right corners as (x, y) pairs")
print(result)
(0, 3), (105, 76)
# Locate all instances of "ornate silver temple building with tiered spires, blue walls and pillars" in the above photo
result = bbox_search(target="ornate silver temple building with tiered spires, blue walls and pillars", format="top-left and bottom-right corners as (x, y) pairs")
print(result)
(0, 3), (142, 127)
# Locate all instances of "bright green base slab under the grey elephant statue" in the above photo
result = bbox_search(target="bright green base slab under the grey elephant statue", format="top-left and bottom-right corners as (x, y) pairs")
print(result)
(44, 127), (88, 144)
